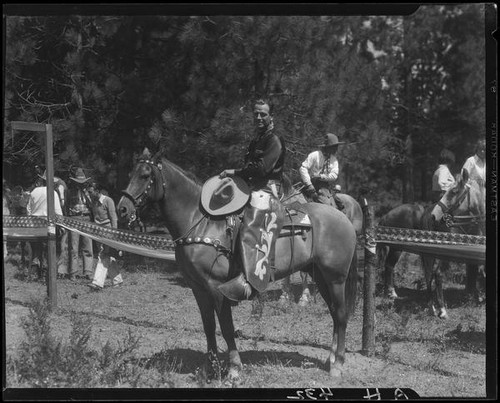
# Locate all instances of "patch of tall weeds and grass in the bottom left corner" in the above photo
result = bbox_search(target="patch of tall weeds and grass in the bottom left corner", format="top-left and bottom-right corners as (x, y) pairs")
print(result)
(7, 300), (184, 388)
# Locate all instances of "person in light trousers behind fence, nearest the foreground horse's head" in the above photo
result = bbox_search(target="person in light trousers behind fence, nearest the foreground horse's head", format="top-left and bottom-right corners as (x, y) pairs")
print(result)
(88, 182), (123, 291)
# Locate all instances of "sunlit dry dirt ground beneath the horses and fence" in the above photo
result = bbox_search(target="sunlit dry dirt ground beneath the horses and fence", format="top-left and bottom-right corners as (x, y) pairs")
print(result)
(4, 246), (486, 398)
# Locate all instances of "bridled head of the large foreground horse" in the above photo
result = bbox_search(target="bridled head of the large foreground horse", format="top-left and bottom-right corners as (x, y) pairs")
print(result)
(116, 148), (165, 227)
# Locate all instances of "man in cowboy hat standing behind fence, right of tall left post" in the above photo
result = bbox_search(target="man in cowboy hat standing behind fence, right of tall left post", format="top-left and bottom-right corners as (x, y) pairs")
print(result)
(68, 168), (94, 280)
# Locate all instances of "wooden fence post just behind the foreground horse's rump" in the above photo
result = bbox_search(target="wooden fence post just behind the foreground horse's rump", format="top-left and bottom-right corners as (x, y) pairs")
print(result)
(361, 199), (377, 355)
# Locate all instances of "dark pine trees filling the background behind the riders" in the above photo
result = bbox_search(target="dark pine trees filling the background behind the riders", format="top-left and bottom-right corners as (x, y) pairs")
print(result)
(3, 4), (485, 215)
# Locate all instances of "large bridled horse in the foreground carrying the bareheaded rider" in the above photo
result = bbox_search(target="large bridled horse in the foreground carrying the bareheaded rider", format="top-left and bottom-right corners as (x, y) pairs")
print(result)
(117, 150), (357, 384)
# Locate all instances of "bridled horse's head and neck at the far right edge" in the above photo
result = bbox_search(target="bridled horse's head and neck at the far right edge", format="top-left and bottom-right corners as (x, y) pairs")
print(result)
(431, 169), (486, 229)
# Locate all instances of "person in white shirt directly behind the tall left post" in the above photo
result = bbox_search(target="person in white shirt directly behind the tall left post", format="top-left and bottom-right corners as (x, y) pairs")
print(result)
(26, 177), (62, 280)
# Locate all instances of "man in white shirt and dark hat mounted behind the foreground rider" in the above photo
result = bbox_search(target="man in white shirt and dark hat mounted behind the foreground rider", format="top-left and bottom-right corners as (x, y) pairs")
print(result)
(299, 133), (344, 210)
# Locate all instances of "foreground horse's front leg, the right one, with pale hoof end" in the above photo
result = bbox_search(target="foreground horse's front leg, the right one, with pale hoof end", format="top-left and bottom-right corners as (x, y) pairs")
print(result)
(218, 298), (243, 386)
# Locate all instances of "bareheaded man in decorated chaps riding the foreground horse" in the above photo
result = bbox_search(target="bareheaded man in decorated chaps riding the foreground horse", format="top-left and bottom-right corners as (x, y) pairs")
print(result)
(219, 100), (285, 301)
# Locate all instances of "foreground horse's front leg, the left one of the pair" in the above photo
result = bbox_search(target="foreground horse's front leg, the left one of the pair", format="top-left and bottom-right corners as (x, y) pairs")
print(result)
(192, 286), (220, 382)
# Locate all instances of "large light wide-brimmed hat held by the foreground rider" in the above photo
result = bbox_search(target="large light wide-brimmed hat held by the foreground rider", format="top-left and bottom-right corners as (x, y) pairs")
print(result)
(201, 176), (250, 216)
